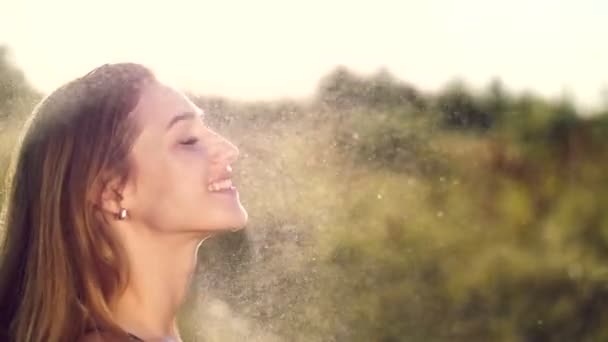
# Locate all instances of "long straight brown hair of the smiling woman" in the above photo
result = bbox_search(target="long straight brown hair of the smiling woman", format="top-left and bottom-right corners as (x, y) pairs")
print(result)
(0, 63), (154, 342)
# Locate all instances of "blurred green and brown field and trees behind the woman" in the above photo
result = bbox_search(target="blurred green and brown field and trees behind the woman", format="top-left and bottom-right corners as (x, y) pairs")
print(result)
(0, 46), (608, 342)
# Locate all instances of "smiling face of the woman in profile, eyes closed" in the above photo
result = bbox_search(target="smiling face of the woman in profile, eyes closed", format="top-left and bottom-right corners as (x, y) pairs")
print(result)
(121, 82), (247, 233)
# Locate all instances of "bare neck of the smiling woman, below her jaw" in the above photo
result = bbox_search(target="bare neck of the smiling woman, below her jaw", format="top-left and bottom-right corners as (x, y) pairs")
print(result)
(107, 229), (203, 341)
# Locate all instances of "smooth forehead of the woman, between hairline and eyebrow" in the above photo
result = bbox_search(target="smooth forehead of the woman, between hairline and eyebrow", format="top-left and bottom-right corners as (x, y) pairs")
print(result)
(132, 82), (201, 125)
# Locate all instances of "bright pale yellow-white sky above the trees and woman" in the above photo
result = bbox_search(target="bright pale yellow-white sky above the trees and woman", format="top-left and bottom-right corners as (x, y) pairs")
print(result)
(0, 0), (608, 104)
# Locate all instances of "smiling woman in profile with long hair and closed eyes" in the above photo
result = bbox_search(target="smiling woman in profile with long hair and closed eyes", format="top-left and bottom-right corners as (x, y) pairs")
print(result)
(0, 63), (247, 342)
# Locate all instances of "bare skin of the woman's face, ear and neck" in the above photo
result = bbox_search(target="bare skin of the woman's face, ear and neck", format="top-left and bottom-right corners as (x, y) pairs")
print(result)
(96, 82), (247, 341)
